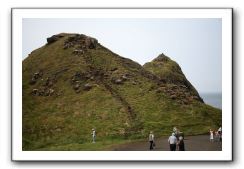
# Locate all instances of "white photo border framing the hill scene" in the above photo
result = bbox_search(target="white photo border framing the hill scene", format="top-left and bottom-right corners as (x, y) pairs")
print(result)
(11, 8), (233, 161)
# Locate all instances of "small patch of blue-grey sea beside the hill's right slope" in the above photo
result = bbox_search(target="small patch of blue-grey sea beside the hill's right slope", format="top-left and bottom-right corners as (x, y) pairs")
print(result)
(200, 93), (222, 109)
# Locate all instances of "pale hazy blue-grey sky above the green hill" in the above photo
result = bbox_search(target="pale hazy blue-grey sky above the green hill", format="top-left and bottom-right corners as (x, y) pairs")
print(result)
(22, 18), (222, 93)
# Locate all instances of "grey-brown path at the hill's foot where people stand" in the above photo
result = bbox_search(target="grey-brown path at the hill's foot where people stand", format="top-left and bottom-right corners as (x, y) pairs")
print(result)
(112, 135), (222, 151)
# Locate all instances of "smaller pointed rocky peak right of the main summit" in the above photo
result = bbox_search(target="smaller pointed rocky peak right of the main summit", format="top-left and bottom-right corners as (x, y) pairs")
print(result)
(143, 54), (203, 104)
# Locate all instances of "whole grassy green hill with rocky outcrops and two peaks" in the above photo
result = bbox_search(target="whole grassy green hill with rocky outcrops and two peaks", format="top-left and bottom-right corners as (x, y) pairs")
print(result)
(22, 33), (221, 150)
